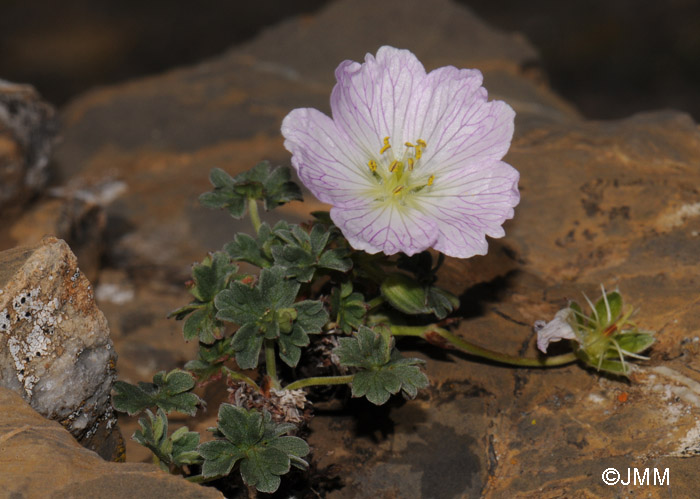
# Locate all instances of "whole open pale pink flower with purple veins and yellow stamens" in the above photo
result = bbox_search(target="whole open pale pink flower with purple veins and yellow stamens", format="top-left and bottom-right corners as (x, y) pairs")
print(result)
(282, 46), (520, 258)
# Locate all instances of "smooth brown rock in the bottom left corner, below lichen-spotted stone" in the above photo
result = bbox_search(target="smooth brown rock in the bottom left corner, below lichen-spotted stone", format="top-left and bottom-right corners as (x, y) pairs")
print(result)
(0, 387), (223, 499)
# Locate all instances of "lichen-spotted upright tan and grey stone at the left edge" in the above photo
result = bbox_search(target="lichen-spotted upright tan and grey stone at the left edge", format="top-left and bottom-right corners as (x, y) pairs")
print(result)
(0, 237), (116, 458)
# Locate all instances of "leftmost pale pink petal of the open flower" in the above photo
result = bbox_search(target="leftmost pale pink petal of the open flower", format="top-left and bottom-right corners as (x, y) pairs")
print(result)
(282, 108), (368, 204)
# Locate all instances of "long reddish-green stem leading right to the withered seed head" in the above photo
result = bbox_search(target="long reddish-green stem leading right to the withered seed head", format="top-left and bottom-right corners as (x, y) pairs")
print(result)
(391, 325), (578, 367)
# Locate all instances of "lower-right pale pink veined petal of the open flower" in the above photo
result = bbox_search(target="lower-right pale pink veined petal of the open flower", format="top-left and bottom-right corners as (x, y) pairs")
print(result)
(420, 161), (520, 258)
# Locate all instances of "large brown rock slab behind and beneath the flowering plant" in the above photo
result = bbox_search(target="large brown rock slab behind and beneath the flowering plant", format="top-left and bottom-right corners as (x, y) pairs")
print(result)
(1, 0), (700, 498)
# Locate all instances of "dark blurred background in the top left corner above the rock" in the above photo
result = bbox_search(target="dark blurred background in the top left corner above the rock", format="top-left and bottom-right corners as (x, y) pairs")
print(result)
(0, 0), (328, 106)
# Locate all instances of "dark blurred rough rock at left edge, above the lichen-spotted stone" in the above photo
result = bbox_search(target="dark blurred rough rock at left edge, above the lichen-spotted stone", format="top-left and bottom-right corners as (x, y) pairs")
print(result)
(0, 80), (57, 215)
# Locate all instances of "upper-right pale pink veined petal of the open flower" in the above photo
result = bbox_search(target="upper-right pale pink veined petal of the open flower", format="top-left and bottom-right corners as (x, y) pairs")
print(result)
(407, 67), (515, 176)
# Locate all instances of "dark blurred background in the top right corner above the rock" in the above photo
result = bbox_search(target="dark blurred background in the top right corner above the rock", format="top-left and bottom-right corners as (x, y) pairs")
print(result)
(458, 0), (700, 121)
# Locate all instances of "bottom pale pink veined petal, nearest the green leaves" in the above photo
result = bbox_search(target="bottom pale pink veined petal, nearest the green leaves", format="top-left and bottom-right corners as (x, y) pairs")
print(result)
(330, 202), (437, 256)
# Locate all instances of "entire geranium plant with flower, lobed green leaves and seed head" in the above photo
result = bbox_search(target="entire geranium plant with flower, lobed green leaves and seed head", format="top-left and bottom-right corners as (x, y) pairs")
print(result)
(113, 47), (653, 492)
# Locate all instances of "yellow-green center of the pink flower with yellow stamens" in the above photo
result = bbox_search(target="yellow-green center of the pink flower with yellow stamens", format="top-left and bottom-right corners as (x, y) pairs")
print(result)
(367, 137), (435, 206)
